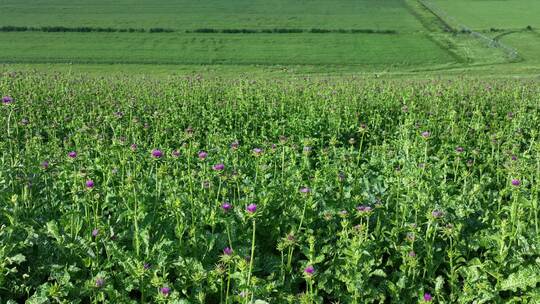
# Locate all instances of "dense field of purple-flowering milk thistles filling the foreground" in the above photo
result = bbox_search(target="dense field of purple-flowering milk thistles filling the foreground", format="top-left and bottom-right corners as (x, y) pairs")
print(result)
(0, 74), (540, 303)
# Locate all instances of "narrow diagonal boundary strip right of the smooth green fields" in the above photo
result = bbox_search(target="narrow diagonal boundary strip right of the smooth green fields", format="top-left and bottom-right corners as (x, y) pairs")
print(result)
(418, 0), (521, 61)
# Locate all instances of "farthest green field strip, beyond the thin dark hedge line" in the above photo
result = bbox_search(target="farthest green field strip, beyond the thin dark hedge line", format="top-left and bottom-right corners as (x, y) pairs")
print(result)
(0, 0), (422, 32)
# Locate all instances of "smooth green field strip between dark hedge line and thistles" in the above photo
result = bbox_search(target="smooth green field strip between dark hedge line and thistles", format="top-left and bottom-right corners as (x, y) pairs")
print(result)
(0, 32), (454, 69)
